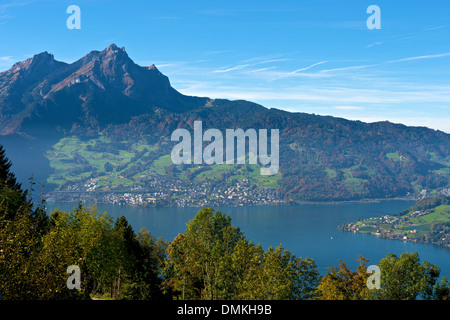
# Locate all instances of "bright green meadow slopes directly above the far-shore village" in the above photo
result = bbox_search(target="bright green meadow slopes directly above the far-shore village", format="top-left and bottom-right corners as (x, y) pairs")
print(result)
(46, 136), (282, 190)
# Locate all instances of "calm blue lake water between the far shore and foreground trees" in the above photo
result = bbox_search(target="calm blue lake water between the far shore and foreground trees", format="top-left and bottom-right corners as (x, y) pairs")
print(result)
(47, 200), (450, 278)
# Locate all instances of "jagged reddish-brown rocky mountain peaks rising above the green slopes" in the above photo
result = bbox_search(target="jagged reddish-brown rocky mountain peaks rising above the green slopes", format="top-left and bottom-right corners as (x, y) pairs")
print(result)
(0, 44), (209, 136)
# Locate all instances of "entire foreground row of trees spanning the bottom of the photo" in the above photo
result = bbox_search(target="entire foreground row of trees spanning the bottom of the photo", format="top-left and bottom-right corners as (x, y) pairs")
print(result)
(0, 147), (450, 300)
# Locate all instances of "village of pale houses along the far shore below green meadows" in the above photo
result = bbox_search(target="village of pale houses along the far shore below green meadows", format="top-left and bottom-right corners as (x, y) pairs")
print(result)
(46, 175), (285, 207)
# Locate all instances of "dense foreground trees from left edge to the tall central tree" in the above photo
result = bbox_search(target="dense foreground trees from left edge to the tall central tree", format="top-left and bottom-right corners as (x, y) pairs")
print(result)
(0, 146), (167, 299)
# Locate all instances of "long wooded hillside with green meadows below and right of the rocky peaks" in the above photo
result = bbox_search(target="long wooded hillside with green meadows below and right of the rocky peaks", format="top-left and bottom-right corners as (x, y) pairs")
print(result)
(41, 100), (450, 201)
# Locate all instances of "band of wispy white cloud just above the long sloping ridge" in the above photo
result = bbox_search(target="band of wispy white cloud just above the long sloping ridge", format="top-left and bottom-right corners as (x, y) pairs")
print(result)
(136, 44), (450, 132)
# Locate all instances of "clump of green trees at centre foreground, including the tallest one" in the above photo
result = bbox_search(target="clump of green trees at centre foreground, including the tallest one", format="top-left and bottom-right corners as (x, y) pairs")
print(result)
(165, 208), (318, 300)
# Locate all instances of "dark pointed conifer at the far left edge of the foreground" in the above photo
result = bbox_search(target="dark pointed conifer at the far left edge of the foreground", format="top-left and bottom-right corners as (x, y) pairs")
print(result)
(0, 146), (49, 299)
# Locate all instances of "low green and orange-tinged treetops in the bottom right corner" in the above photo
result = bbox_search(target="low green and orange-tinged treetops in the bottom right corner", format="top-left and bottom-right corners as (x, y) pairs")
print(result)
(315, 253), (444, 300)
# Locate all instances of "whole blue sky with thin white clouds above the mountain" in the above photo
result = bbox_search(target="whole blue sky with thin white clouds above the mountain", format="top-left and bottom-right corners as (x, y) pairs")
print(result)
(0, 0), (450, 133)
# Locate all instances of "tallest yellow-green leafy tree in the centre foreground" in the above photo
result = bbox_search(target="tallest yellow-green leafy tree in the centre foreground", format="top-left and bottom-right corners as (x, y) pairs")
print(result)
(166, 208), (243, 300)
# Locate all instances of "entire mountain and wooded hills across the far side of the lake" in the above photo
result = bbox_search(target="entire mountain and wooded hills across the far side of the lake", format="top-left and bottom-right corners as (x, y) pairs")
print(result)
(0, 44), (450, 201)
